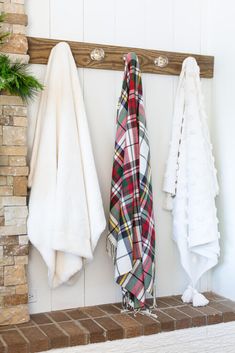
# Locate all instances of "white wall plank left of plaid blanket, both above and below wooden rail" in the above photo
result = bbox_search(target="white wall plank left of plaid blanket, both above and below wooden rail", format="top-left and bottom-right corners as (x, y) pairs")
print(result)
(84, 0), (119, 305)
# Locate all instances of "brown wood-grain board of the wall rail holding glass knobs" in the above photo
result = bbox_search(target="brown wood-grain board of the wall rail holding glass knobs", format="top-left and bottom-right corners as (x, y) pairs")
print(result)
(28, 37), (214, 78)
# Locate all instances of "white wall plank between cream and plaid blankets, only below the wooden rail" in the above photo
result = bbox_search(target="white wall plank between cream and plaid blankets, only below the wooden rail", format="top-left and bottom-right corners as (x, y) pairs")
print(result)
(84, 70), (116, 305)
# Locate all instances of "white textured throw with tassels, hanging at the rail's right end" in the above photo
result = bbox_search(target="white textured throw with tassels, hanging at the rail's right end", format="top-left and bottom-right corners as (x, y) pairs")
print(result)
(163, 57), (220, 306)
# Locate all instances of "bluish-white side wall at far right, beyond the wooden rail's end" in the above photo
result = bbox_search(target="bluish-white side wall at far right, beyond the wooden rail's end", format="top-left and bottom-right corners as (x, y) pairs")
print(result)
(209, 0), (235, 300)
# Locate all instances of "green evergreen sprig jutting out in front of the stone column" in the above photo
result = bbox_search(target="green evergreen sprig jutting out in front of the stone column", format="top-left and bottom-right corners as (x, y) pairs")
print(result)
(0, 55), (43, 102)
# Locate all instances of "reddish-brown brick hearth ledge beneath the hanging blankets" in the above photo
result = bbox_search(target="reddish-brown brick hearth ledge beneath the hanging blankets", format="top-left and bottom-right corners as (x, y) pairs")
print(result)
(0, 292), (235, 353)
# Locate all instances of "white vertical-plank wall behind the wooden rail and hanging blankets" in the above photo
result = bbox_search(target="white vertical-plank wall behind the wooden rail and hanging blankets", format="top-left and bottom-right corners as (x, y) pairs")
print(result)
(26, 0), (211, 312)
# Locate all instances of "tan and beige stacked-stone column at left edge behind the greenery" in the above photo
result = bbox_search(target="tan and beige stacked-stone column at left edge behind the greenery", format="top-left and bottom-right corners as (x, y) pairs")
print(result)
(0, 0), (29, 325)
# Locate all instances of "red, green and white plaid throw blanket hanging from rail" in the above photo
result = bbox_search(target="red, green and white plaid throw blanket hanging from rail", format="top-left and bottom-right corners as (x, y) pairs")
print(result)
(107, 53), (155, 309)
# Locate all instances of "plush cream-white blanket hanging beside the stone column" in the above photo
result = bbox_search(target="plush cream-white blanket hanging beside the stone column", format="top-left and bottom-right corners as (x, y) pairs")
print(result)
(28, 43), (106, 287)
